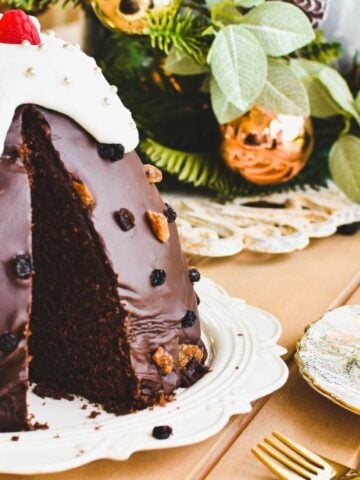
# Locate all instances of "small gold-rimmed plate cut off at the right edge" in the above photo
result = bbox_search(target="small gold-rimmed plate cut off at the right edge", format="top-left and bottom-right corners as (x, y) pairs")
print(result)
(295, 305), (360, 415)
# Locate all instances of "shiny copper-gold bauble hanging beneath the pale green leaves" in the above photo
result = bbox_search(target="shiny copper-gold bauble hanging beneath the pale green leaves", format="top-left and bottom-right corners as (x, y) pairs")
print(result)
(221, 107), (314, 185)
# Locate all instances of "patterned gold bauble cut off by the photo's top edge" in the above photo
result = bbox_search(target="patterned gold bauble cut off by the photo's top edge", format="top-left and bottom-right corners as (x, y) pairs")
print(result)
(91, 0), (175, 35)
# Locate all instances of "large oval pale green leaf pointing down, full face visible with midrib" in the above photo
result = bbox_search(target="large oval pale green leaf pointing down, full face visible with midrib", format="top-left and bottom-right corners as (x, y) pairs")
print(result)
(208, 25), (267, 111)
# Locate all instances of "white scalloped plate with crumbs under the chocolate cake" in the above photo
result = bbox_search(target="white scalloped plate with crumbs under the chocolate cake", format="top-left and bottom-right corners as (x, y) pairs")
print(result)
(0, 279), (288, 474)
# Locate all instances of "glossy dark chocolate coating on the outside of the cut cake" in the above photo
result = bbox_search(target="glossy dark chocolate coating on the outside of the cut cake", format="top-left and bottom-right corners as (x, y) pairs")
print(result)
(0, 106), (202, 431)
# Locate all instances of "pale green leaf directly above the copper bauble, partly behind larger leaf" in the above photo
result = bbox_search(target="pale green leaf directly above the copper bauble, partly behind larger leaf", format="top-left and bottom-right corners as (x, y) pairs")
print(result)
(256, 60), (310, 117)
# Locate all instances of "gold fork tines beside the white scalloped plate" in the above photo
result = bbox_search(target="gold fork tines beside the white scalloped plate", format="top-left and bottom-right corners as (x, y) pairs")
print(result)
(251, 432), (360, 480)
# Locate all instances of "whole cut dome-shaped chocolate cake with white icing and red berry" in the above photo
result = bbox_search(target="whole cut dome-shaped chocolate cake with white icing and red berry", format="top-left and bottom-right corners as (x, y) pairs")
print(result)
(0, 10), (206, 432)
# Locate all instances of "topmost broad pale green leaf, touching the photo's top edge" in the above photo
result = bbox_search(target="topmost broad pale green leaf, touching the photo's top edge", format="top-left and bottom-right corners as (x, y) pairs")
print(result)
(242, 1), (315, 57)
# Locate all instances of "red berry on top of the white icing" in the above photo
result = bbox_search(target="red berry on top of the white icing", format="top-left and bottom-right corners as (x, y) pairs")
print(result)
(0, 10), (41, 45)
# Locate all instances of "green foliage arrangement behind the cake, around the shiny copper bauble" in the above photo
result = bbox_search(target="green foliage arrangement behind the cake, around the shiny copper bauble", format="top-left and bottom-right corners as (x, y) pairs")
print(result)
(7, 0), (360, 202)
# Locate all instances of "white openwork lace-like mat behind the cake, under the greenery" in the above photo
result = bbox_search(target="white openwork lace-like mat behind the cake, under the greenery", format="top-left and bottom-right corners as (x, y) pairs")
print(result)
(164, 184), (360, 257)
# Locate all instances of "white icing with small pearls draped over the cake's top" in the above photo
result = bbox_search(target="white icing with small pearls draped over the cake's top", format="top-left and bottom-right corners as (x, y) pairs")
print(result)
(0, 16), (139, 152)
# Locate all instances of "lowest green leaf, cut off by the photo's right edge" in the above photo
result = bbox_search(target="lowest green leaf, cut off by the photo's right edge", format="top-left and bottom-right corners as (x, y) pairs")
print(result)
(329, 135), (360, 203)
